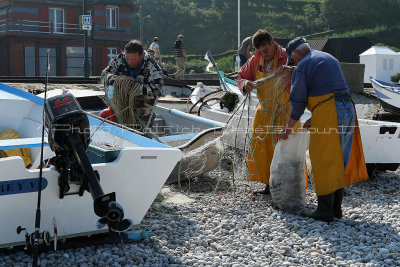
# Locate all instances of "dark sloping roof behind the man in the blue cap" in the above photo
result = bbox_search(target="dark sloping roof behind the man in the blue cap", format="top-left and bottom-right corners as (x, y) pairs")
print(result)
(275, 36), (372, 63)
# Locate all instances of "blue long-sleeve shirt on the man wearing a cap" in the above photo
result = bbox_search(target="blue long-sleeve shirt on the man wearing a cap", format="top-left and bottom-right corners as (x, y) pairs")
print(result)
(289, 50), (350, 120)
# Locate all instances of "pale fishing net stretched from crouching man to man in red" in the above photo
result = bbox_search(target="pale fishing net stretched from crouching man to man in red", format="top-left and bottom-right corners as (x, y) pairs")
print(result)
(96, 74), (300, 198)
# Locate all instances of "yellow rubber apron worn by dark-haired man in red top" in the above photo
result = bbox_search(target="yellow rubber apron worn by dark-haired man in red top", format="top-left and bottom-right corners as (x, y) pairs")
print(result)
(247, 55), (291, 184)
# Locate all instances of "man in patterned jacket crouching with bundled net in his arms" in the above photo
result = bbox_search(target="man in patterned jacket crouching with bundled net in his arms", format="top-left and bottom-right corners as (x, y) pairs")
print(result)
(100, 40), (163, 130)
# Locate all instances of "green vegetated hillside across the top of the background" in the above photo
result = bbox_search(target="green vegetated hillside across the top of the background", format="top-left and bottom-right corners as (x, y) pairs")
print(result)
(132, 0), (400, 55)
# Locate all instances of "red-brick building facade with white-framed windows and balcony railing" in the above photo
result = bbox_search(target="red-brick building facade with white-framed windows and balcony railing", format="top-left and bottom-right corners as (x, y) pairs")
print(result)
(0, 0), (136, 76)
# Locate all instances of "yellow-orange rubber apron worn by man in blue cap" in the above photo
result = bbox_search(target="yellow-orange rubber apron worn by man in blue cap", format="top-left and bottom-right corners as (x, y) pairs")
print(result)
(307, 94), (368, 196)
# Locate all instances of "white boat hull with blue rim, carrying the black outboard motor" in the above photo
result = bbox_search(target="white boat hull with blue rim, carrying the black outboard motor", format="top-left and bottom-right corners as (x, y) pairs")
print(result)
(0, 84), (182, 247)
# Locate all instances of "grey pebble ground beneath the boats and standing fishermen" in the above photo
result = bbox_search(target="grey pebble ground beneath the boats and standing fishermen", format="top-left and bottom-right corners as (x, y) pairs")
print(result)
(0, 83), (400, 266)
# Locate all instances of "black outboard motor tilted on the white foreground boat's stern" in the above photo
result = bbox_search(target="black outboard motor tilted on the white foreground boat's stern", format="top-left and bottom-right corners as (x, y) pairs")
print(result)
(45, 92), (133, 232)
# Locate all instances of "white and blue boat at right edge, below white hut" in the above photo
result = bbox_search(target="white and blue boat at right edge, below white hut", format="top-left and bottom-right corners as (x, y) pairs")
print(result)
(369, 77), (400, 115)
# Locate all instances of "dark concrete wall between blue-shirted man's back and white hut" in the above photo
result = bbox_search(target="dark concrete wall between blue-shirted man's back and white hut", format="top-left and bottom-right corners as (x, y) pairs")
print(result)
(340, 62), (365, 93)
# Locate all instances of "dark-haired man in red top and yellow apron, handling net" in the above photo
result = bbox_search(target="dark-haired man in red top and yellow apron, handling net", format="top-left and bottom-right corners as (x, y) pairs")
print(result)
(237, 29), (290, 195)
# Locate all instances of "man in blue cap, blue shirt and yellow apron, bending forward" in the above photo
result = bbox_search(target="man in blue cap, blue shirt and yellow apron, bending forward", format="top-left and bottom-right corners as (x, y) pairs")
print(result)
(279, 37), (368, 222)
